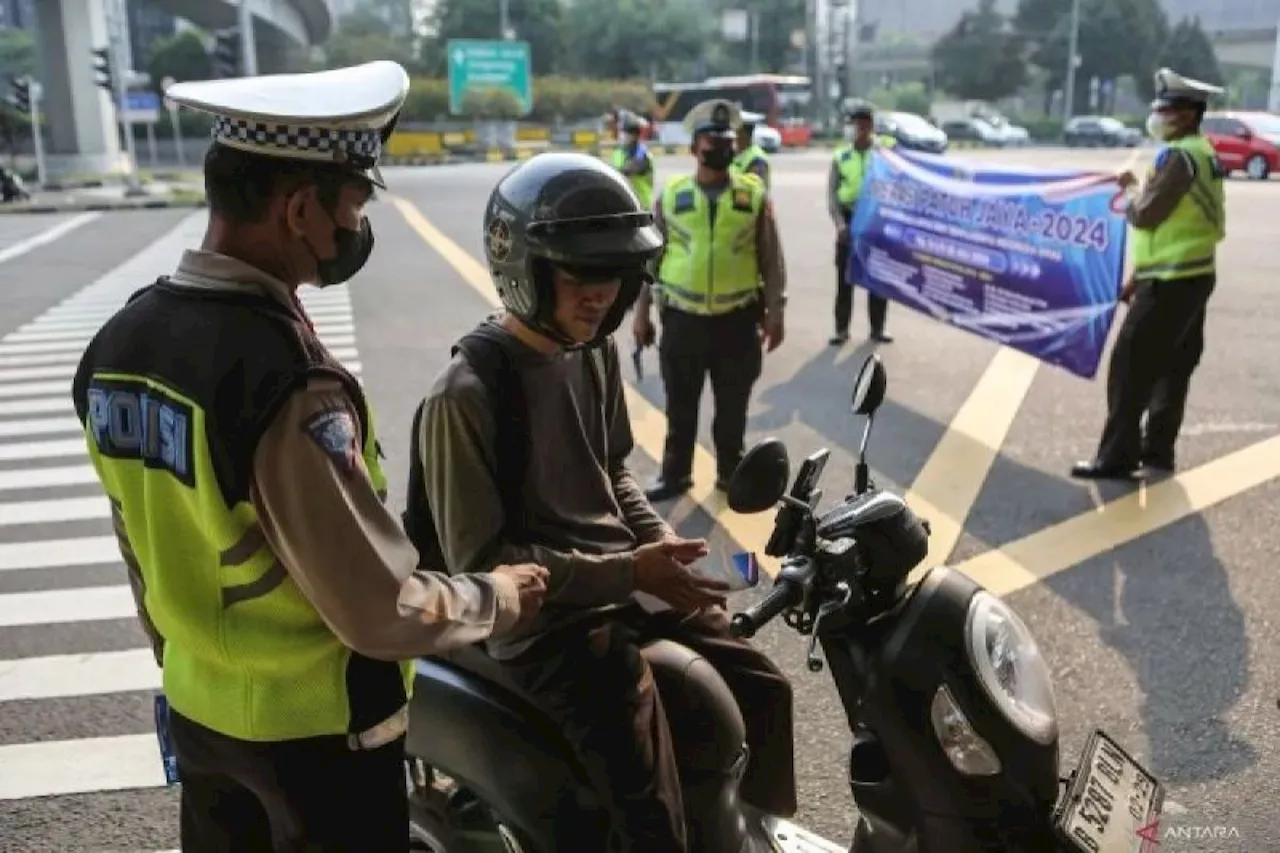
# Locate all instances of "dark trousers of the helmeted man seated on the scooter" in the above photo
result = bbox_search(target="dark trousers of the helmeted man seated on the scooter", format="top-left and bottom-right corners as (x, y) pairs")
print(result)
(503, 607), (796, 853)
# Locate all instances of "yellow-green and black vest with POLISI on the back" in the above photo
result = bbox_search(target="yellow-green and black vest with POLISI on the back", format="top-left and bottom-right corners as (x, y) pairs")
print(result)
(73, 279), (413, 742)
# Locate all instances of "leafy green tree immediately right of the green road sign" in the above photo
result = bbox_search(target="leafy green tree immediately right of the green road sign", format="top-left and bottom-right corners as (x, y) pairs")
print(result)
(564, 0), (708, 79)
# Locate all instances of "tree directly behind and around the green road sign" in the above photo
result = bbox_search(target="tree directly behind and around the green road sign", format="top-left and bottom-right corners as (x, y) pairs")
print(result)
(422, 0), (567, 76)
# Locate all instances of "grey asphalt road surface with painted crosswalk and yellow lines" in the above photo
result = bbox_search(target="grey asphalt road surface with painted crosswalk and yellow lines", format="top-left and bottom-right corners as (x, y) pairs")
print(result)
(0, 151), (1280, 852)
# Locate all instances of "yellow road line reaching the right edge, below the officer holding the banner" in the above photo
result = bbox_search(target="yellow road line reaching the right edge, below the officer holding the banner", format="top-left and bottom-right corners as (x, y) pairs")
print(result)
(956, 435), (1280, 596)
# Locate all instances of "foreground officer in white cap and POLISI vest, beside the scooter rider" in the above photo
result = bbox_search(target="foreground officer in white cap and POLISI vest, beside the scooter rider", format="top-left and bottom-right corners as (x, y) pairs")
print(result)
(72, 61), (547, 853)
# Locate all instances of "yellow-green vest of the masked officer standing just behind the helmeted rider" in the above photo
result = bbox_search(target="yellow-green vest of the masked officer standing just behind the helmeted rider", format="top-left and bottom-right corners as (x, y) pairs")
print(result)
(658, 173), (765, 314)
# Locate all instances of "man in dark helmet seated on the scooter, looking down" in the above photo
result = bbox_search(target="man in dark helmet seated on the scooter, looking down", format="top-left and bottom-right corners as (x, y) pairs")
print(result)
(419, 154), (795, 853)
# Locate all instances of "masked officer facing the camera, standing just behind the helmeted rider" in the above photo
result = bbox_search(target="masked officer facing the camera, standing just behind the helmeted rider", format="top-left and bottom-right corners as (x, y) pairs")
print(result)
(634, 100), (786, 501)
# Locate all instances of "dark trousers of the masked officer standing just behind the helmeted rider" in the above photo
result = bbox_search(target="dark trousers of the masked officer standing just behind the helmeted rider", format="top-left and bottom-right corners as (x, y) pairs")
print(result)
(658, 305), (763, 483)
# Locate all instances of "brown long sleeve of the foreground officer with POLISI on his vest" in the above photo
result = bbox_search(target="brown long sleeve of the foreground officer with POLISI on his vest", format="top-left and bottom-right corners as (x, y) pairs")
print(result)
(251, 379), (520, 660)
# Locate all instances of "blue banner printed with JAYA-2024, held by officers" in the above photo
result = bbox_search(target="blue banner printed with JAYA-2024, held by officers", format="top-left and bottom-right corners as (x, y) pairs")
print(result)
(845, 150), (1128, 379)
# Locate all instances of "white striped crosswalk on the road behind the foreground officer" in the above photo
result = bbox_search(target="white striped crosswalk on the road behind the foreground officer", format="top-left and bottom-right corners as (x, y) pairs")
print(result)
(0, 208), (362, 849)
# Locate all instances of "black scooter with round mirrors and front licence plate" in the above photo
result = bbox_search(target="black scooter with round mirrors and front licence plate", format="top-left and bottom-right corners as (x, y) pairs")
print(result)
(407, 356), (1164, 853)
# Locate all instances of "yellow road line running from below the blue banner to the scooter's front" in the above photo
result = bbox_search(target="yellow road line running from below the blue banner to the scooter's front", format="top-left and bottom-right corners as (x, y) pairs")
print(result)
(906, 347), (1039, 566)
